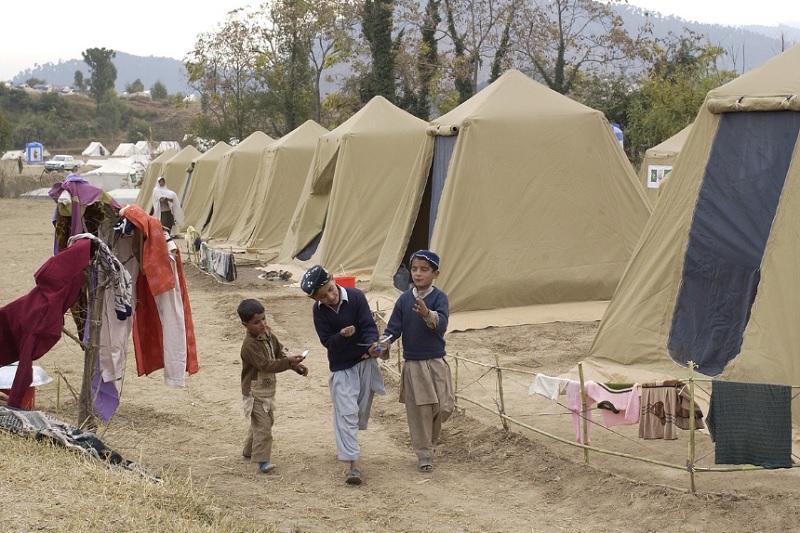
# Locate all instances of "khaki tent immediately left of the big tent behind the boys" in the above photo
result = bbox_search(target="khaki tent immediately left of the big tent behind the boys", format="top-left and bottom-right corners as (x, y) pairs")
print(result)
(278, 96), (427, 273)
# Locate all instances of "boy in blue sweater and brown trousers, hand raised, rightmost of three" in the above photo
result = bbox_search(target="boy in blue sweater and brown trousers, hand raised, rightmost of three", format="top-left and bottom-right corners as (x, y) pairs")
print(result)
(371, 250), (455, 473)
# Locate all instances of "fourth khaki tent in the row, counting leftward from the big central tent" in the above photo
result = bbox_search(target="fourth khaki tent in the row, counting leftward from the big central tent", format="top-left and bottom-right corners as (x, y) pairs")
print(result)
(202, 131), (274, 240)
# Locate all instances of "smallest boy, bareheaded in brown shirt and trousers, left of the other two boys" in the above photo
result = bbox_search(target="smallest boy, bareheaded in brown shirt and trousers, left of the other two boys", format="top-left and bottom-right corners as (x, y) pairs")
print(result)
(236, 299), (308, 474)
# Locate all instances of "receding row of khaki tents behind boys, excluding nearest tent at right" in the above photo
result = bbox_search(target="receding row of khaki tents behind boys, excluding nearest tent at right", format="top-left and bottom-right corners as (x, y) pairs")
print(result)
(137, 70), (651, 318)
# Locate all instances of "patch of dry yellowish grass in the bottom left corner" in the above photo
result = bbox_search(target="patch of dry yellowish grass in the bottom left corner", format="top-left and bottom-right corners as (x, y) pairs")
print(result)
(0, 430), (277, 533)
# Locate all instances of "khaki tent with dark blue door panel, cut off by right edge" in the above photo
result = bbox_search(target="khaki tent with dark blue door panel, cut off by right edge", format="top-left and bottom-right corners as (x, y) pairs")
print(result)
(584, 42), (800, 424)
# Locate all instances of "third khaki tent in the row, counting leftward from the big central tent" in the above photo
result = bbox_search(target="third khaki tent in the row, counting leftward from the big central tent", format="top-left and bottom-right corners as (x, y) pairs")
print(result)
(228, 120), (328, 249)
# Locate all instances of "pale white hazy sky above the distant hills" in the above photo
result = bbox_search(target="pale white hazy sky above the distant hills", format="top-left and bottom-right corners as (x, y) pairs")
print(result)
(0, 0), (800, 80)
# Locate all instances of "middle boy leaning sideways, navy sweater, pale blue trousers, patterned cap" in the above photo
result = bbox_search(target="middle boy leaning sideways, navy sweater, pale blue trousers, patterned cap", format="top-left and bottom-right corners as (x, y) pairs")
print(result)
(300, 265), (386, 485)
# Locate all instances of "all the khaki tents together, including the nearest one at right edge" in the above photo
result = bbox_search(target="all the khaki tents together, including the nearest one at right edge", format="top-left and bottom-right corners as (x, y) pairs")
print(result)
(139, 42), (800, 423)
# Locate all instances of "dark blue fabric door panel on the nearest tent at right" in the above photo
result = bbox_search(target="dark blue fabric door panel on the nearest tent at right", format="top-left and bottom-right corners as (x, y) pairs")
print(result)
(667, 111), (800, 376)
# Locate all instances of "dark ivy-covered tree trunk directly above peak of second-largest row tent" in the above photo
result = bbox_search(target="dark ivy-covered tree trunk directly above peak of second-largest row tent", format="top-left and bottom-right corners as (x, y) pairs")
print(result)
(361, 0), (396, 103)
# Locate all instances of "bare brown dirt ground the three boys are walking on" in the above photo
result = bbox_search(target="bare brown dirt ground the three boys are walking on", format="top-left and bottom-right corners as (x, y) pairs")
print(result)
(0, 199), (800, 533)
